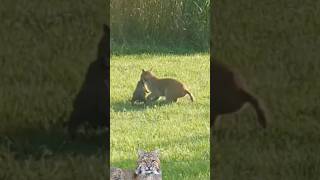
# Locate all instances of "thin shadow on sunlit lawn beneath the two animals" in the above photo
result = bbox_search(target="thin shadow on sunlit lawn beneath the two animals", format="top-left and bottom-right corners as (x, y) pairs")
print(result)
(110, 100), (172, 112)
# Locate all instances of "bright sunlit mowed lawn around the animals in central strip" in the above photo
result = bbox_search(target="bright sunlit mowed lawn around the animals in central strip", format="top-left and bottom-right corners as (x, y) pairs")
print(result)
(110, 53), (210, 180)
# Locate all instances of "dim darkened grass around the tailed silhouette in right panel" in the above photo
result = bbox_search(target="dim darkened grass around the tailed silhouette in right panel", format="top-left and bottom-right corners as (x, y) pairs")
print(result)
(211, 0), (320, 180)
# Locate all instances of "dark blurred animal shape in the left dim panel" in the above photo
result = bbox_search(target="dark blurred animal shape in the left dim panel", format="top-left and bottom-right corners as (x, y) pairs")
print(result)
(67, 25), (110, 138)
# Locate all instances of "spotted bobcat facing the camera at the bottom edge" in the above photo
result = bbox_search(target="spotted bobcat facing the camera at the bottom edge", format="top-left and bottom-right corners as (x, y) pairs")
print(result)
(110, 150), (162, 180)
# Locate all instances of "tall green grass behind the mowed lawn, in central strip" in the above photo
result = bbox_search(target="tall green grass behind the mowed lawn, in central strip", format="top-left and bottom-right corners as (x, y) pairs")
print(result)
(110, 0), (210, 49)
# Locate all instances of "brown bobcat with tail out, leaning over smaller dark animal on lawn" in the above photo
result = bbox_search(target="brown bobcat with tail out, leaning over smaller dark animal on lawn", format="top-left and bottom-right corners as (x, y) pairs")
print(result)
(140, 69), (194, 102)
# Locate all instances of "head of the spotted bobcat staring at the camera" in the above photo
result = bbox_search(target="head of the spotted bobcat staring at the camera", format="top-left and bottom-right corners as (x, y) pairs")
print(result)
(136, 150), (161, 175)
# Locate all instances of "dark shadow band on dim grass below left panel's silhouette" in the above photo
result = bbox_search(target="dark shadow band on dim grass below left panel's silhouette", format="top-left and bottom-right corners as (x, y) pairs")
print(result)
(0, 125), (108, 159)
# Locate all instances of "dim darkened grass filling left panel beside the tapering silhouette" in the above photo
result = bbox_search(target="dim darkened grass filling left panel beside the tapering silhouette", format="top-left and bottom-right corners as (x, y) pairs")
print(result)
(0, 0), (107, 180)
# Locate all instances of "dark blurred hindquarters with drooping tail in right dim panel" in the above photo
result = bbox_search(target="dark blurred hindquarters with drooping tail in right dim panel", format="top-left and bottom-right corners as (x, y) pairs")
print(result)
(210, 42), (267, 128)
